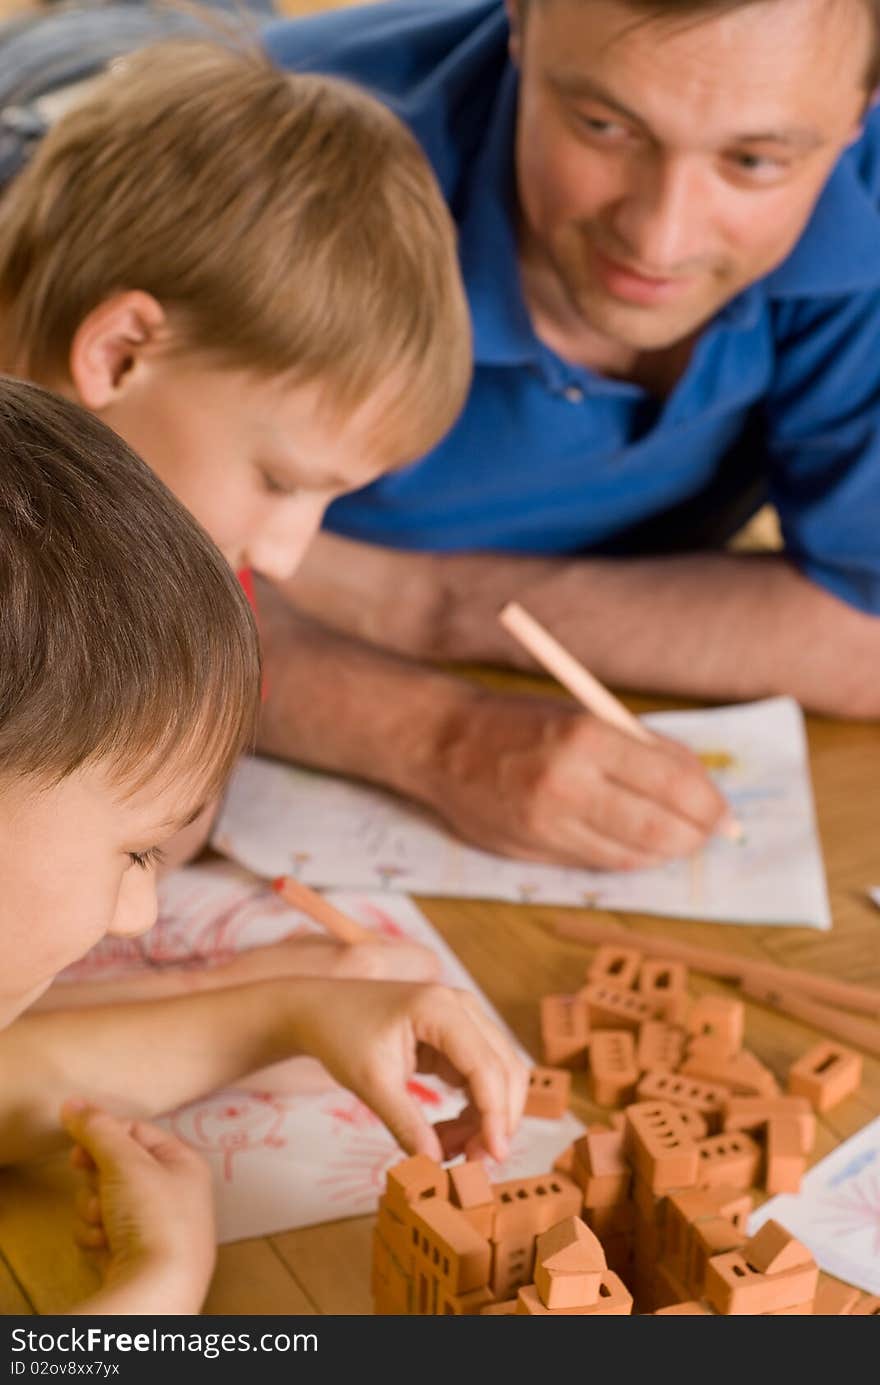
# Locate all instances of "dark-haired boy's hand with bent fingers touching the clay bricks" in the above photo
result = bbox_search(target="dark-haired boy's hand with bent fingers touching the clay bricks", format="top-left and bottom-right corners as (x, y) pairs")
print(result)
(293, 981), (528, 1162)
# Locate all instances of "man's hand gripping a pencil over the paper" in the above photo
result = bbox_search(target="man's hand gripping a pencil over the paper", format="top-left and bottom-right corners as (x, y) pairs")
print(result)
(424, 690), (729, 870)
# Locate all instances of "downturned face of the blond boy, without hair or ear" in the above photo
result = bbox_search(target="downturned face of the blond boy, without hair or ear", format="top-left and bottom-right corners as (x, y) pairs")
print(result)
(100, 357), (389, 580)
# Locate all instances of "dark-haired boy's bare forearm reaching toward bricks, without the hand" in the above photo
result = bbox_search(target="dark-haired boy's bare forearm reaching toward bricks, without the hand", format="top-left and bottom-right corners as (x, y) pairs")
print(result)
(0, 979), (315, 1163)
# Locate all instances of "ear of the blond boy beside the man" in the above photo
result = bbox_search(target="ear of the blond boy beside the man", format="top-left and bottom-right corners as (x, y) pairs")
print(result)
(69, 289), (166, 413)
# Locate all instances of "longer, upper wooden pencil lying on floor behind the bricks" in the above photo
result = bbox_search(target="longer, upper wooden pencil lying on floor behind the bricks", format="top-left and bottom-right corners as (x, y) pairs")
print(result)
(553, 917), (880, 1019)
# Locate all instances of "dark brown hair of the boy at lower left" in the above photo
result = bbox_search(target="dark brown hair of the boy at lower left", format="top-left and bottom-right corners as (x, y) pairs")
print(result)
(0, 377), (259, 798)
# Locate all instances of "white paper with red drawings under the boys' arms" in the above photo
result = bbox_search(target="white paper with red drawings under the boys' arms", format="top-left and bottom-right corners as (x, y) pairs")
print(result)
(64, 863), (583, 1241)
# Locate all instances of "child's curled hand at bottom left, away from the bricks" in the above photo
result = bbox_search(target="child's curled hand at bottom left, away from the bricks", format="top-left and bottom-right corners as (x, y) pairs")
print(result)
(61, 1101), (216, 1313)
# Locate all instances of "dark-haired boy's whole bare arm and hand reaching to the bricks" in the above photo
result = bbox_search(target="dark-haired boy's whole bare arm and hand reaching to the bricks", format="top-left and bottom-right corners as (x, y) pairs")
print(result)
(0, 978), (527, 1163)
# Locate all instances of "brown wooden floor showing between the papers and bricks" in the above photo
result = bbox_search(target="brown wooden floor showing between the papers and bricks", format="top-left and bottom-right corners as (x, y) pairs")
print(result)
(0, 702), (880, 1314)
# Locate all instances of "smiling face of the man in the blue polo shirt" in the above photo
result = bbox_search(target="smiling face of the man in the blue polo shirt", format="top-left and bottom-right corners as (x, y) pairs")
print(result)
(511, 0), (872, 350)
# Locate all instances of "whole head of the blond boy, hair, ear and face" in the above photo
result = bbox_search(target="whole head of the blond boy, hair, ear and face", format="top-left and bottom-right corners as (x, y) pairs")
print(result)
(0, 40), (471, 576)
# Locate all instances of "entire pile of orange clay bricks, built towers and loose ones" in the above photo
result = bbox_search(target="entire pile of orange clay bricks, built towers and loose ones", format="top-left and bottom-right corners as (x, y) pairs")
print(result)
(373, 947), (880, 1316)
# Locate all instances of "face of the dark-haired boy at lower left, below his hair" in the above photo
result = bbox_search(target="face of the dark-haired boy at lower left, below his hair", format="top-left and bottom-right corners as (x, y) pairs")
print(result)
(0, 766), (201, 1028)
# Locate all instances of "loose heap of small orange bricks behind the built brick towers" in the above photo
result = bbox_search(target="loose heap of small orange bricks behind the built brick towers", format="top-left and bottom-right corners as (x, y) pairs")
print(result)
(540, 946), (862, 1192)
